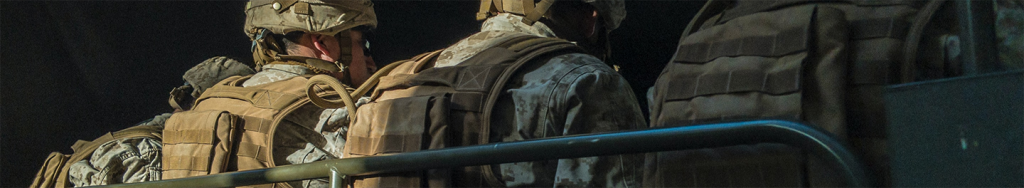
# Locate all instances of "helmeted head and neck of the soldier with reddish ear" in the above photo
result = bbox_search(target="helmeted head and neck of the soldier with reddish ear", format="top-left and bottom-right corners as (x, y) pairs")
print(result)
(245, 0), (377, 86)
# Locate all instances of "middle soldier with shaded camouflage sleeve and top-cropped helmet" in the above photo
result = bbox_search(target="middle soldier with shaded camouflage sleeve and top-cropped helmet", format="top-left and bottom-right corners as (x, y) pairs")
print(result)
(345, 0), (645, 187)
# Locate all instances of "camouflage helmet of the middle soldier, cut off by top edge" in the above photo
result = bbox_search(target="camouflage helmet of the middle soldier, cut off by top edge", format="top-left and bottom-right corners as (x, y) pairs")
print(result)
(476, 0), (626, 31)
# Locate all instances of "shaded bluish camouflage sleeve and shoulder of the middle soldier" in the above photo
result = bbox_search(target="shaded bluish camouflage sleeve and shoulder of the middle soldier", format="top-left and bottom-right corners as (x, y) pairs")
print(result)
(496, 54), (645, 187)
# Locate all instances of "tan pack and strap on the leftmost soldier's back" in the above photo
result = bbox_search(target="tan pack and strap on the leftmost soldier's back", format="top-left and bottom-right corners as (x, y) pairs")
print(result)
(29, 126), (162, 188)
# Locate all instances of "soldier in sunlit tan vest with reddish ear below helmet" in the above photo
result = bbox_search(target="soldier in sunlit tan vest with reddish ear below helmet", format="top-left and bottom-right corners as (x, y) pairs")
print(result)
(163, 0), (377, 187)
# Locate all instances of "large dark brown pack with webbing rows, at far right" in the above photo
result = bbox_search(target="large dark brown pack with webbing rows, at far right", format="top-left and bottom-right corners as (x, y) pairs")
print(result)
(645, 0), (945, 187)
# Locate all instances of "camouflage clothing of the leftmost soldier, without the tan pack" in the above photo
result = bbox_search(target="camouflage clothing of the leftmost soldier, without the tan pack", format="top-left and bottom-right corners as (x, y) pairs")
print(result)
(68, 56), (253, 187)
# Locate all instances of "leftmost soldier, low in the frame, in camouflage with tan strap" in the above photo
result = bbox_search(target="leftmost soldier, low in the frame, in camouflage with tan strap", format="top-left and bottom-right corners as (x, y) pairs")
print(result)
(32, 56), (254, 187)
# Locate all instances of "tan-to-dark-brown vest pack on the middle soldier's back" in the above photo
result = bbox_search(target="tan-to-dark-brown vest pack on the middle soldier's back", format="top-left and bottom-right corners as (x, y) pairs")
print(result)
(344, 36), (582, 188)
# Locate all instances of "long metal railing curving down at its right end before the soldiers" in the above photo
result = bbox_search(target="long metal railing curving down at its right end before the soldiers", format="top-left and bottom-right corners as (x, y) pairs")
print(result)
(88, 121), (870, 188)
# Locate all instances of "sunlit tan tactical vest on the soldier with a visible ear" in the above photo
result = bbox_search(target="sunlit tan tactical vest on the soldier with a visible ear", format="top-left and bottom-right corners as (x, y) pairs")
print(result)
(163, 76), (336, 187)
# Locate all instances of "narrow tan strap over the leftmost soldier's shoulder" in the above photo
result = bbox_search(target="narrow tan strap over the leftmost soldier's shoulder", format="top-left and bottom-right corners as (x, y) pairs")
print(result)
(55, 126), (164, 188)
